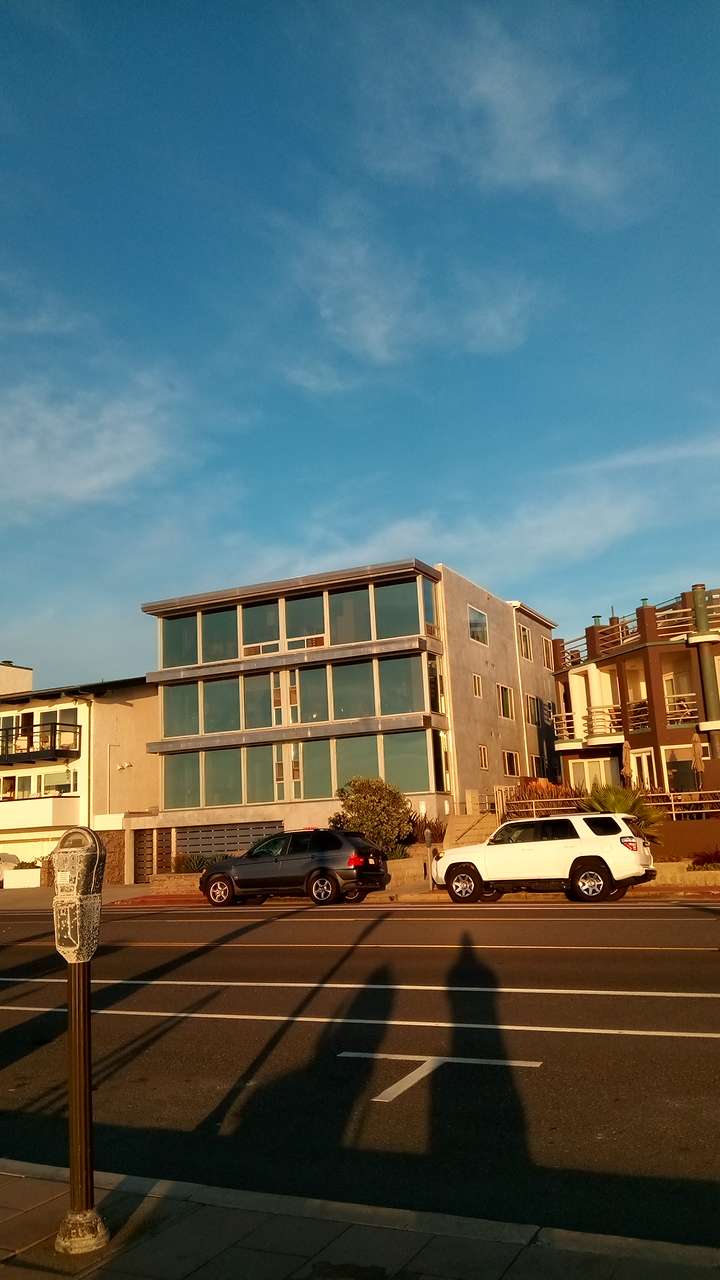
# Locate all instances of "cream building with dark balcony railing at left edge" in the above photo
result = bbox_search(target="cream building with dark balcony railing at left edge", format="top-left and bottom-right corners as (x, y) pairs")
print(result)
(0, 662), (159, 883)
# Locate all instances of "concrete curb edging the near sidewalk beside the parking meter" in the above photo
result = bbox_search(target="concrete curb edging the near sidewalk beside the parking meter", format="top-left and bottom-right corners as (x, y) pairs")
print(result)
(0, 1158), (720, 1270)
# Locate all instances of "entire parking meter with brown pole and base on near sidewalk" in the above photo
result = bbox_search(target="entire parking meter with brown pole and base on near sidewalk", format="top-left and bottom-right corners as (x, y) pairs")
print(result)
(53, 827), (109, 1253)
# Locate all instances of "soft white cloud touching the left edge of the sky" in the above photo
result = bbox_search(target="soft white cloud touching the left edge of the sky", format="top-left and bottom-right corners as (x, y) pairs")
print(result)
(0, 375), (173, 522)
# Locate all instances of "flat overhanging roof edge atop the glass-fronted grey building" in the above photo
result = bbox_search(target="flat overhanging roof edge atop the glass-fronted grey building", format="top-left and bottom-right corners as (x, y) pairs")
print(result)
(140, 559), (442, 617)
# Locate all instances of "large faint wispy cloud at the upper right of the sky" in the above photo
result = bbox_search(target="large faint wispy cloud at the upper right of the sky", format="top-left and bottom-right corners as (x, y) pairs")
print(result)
(359, 4), (659, 219)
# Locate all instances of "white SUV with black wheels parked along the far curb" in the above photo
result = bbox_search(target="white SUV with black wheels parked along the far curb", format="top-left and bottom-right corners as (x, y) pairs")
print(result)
(433, 813), (657, 902)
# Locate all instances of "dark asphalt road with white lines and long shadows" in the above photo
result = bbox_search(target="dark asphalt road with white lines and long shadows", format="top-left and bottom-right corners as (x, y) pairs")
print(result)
(0, 901), (720, 1244)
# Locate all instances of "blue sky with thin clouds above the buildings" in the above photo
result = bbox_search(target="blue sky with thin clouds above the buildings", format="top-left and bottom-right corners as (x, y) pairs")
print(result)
(0, 0), (720, 686)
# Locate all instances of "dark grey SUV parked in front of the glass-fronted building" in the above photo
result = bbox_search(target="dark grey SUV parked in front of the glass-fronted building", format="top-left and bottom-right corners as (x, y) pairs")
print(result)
(200, 827), (389, 906)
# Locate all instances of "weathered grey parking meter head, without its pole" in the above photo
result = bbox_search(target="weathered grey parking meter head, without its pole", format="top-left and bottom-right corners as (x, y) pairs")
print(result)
(53, 827), (106, 964)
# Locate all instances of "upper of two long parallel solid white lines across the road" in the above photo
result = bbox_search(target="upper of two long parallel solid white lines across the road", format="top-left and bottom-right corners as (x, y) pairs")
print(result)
(0, 974), (720, 1000)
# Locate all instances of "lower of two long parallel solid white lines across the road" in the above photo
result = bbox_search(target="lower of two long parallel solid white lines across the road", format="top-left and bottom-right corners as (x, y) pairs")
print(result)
(0, 1005), (720, 1041)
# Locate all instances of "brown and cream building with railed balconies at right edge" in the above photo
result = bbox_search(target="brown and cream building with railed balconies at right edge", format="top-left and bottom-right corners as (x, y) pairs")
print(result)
(553, 584), (720, 791)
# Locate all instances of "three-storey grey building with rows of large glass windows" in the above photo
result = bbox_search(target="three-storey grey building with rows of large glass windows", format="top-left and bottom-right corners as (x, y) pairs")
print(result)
(139, 559), (555, 851)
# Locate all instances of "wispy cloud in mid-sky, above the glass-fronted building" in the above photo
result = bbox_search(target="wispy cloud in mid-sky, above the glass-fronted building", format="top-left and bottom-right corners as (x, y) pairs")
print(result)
(278, 201), (541, 381)
